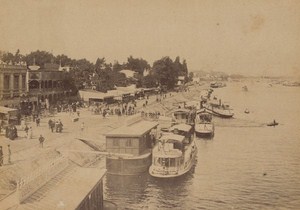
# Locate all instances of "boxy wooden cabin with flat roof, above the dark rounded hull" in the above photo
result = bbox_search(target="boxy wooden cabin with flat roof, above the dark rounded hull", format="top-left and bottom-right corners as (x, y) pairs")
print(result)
(105, 120), (158, 156)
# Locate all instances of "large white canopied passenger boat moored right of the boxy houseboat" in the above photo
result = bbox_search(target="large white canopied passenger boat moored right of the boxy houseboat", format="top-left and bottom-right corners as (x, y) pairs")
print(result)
(149, 125), (197, 178)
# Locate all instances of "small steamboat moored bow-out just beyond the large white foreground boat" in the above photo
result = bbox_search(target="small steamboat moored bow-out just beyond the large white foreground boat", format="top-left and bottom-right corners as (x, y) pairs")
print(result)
(195, 109), (215, 138)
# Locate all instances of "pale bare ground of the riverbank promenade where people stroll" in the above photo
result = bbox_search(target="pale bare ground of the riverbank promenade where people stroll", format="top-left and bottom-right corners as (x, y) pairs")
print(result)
(0, 85), (206, 202)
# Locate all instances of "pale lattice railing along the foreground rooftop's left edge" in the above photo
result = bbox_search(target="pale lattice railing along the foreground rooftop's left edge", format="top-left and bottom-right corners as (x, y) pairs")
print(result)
(17, 156), (69, 203)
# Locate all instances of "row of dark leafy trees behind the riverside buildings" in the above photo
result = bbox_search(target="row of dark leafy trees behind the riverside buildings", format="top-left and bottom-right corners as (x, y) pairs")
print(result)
(0, 50), (191, 92)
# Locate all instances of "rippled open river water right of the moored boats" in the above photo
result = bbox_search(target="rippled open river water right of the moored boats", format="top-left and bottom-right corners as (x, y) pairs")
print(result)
(104, 82), (300, 210)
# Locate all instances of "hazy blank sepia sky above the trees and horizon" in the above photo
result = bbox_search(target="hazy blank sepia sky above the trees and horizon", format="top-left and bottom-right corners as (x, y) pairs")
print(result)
(0, 0), (300, 75)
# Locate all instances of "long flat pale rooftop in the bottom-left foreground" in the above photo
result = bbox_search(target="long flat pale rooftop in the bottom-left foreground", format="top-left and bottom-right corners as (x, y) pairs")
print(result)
(17, 166), (106, 210)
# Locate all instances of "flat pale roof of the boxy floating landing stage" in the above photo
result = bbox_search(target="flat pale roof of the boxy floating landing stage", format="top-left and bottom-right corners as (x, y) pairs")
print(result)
(105, 120), (158, 137)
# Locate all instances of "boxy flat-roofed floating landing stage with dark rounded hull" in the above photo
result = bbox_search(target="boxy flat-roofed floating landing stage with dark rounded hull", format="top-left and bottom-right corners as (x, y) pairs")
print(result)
(105, 120), (158, 175)
